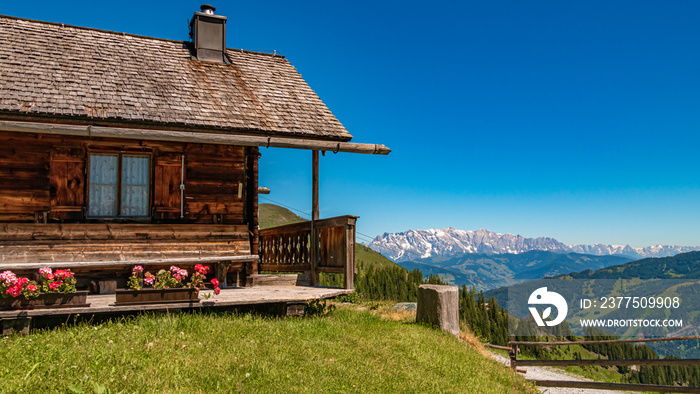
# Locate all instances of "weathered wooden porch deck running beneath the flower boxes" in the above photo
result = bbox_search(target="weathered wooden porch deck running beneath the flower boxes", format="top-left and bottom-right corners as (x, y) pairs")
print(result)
(0, 286), (353, 331)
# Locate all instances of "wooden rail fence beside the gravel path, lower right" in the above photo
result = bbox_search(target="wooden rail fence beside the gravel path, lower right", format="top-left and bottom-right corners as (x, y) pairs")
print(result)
(508, 335), (700, 393)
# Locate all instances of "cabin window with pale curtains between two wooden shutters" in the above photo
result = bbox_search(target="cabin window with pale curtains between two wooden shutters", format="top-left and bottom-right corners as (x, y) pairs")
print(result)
(88, 153), (150, 218)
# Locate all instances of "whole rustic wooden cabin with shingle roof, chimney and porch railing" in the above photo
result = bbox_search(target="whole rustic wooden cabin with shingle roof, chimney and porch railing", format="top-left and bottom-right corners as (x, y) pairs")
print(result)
(0, 6), (389, 292)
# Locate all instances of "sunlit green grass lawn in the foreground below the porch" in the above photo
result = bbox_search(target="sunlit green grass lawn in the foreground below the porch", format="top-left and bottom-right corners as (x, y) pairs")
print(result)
(0, 309), (534, 393)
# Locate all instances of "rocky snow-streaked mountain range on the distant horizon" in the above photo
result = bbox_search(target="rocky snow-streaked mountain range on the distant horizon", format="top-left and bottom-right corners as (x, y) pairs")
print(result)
(367, 227), (700, 261)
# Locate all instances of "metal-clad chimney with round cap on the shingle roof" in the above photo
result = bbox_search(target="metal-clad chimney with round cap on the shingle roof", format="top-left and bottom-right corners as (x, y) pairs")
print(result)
(190, 4), (228, 63)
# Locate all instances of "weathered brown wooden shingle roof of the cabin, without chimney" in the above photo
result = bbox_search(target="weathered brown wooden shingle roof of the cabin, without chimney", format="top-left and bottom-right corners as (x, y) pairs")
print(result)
(0, 16), (352, 141)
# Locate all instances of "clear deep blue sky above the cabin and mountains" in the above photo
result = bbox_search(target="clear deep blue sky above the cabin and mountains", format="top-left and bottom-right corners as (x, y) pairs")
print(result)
(6, 0), (700, 247)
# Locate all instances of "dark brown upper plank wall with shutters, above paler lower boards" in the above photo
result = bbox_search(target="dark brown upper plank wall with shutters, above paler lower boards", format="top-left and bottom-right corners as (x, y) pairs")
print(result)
(0, 131), (250, 226)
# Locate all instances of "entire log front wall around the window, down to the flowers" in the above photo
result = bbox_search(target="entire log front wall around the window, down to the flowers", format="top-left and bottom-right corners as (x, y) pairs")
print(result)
(0, 130), (258, 285)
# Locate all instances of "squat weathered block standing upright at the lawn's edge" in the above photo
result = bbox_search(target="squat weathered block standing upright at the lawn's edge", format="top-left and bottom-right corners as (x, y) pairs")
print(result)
(416, 285), (459, 336)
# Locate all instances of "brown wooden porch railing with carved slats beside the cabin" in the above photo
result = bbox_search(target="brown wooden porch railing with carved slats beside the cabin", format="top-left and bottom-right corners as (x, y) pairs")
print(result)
(258, 215), (357, 289)
